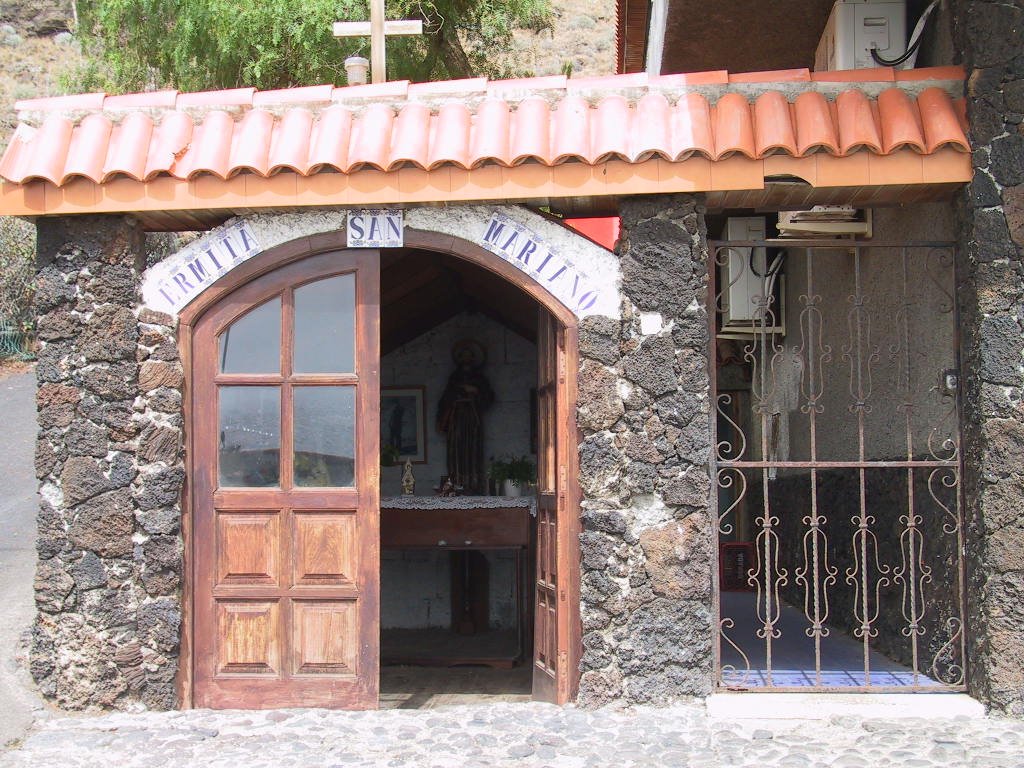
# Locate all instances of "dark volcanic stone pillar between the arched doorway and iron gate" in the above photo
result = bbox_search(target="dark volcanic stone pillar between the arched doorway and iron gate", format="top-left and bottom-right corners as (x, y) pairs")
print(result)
(578, 196), (715, 706)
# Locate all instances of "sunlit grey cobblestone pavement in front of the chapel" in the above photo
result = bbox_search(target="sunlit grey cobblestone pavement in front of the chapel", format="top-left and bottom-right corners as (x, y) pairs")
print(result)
(0, 703), (1024, 768)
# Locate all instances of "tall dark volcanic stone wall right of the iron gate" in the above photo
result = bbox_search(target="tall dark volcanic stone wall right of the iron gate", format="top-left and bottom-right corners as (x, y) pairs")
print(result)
(954, 0), (1024, 716)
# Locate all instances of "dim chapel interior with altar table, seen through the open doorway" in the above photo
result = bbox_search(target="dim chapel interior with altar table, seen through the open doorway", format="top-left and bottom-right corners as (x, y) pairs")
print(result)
(380, 248), (539, 709)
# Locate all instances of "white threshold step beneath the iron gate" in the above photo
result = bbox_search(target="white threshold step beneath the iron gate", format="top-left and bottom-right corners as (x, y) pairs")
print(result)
(706, 691), (985, 721)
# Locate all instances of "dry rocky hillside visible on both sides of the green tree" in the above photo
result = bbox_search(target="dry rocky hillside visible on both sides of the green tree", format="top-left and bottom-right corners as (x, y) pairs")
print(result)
(0, 0), (615, 144)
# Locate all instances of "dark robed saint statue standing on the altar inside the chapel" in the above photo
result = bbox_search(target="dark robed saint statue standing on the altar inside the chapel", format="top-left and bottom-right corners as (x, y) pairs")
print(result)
(437, 341), (495, 494)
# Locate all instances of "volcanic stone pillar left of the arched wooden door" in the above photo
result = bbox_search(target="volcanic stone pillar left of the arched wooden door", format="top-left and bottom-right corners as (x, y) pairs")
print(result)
(30, 216), (184, 709)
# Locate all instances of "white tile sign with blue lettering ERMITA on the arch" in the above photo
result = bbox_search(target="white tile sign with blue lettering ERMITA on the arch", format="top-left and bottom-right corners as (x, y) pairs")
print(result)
(142, 220), (263, 314)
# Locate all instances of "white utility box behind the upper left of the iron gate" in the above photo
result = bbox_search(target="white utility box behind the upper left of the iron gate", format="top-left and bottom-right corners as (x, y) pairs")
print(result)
(720, 216), (782, 333)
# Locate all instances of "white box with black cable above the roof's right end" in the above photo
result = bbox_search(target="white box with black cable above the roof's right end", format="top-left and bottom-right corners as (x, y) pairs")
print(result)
(814, 0), (906, 72)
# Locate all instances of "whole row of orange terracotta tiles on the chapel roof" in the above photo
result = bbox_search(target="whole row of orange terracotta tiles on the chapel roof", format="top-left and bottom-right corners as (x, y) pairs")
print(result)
(0, 68), (970, 185)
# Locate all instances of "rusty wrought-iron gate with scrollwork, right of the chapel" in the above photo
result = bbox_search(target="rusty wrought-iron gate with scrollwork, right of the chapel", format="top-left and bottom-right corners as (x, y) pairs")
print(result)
(710, 240), (966, 691)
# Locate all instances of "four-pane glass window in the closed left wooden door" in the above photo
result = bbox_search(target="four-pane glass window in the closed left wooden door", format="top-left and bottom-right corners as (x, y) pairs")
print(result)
(217, 272), (358, 489)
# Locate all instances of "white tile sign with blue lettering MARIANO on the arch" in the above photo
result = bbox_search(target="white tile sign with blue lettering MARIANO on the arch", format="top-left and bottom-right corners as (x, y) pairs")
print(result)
(477, 211), (602, 316)
